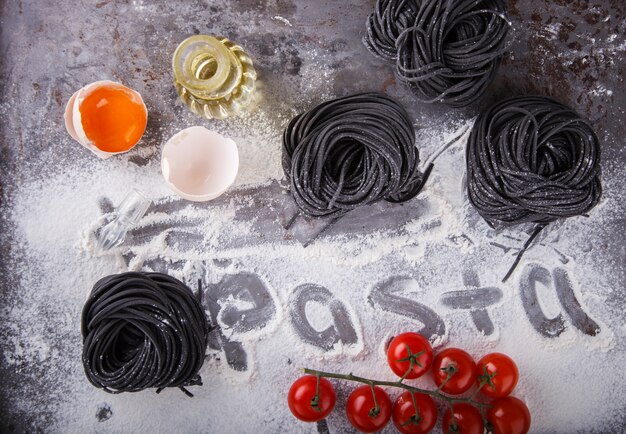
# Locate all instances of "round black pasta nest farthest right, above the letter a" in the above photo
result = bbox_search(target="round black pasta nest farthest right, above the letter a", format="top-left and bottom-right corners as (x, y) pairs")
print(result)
(466, 96), (602, 227)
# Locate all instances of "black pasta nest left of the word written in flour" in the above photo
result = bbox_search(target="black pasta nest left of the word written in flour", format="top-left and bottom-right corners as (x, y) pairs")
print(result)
(82, 272), (209, 396)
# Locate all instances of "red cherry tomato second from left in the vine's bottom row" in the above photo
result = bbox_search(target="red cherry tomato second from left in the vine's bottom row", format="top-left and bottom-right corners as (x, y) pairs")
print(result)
(346, 385), (391, 432)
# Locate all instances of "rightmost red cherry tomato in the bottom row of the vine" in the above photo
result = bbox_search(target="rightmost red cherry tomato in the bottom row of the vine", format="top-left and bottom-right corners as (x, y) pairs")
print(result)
(487, 396), (530, 434)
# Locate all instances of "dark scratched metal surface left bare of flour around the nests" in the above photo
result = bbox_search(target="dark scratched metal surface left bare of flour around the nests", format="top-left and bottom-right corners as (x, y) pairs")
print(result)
(0, 0), (626, 432)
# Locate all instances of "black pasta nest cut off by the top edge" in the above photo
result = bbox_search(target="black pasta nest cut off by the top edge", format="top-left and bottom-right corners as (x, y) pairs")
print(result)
(363, 0), (509, 107)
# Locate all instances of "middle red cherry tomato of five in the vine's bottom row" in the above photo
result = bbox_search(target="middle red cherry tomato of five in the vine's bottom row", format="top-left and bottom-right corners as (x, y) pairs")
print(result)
(391, 391), (437, 434)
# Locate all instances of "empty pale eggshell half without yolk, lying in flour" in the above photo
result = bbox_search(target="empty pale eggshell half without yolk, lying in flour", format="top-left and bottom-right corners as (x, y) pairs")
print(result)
(161, 126), (239, 202)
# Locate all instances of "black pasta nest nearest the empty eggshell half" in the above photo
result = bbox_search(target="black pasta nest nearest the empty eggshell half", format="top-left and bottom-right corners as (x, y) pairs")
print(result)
(283, 93), (426, 217)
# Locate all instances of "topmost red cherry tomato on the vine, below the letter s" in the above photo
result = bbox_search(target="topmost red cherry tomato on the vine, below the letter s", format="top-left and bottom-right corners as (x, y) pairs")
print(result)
(387, 332), (433, 378)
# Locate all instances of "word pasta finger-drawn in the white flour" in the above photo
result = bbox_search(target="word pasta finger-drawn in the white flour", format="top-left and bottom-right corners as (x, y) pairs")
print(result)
(193, 265), (600, 371)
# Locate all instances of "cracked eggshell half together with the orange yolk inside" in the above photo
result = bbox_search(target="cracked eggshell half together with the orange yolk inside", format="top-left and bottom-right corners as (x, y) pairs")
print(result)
(64, 80), (148, 158)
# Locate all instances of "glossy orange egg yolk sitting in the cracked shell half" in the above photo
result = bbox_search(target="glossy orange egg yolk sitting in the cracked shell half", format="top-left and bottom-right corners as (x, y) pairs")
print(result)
(79, 85), (148, 152)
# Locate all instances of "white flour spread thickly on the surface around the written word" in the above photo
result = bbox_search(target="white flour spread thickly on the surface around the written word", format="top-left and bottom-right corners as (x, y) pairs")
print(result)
(4, 94), (624, 432)
